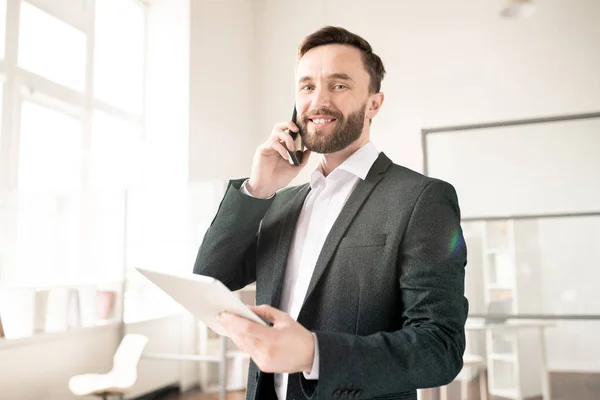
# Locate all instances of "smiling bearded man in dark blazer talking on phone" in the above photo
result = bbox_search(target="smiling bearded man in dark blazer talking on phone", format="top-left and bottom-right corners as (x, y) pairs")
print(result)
(194, 27), (468, 400)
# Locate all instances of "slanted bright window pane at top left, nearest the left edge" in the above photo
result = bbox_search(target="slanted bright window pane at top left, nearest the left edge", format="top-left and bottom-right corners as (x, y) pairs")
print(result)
(18, 2), (86, 91)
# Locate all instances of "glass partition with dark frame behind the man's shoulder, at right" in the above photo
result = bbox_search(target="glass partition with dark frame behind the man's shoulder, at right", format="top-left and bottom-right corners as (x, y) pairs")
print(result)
(422, 113), (600, 400)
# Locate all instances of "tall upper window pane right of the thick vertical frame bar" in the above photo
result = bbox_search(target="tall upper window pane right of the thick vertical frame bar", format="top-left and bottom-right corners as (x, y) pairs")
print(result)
(94, 0), (145, 113)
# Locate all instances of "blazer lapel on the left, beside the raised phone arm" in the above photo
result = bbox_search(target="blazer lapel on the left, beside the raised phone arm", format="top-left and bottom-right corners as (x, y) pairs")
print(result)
(269, 184), (310, 308)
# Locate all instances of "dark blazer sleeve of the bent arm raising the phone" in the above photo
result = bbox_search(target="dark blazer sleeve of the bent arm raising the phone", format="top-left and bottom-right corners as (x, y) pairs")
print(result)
(194, 179), (273, 290)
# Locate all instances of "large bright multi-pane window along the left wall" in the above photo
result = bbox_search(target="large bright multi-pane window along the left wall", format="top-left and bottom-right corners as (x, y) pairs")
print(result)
(0, 0), (146, 336)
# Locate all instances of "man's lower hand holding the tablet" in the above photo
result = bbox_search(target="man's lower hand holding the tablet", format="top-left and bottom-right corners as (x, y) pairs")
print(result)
(218, 304), (315, 373)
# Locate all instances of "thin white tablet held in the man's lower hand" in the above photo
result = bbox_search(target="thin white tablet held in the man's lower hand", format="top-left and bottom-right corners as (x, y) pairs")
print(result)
(136, 267), (267, 336)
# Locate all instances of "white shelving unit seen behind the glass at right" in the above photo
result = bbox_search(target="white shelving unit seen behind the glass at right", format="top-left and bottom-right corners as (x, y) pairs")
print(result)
(480, 219), (541, 400)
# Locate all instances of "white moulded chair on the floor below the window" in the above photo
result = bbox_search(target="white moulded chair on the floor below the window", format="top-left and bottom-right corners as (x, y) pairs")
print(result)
(69, 334), (148, 400)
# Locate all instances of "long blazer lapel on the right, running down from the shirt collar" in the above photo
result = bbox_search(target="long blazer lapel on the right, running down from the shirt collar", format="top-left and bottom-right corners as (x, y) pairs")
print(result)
(300, 153), (392, 313)
